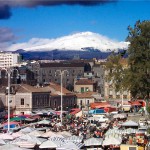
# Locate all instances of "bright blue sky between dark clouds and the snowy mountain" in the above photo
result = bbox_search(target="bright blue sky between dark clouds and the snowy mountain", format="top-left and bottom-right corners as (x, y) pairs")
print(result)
(0, 0), (150, 47)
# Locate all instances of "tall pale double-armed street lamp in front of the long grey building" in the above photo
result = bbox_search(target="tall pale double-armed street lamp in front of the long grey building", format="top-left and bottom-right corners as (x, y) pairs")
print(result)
(56, 70), (69, 125)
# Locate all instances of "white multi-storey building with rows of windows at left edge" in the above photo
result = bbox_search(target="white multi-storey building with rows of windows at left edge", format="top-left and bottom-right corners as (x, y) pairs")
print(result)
(0, 52), (21, 69)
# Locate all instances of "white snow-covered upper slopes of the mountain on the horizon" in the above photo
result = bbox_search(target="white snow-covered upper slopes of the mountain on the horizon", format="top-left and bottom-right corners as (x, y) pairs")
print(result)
(8, 32), (128, 52)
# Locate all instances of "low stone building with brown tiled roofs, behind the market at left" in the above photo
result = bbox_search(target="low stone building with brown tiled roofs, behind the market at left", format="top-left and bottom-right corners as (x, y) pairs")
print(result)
(0, 83), (76, 114)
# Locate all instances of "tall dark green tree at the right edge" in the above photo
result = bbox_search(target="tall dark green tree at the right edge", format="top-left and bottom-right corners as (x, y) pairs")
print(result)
(127, 21), (150, 98)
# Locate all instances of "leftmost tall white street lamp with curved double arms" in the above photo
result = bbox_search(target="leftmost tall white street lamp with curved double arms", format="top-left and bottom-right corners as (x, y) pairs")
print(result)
(1, 67), (19, 133)
